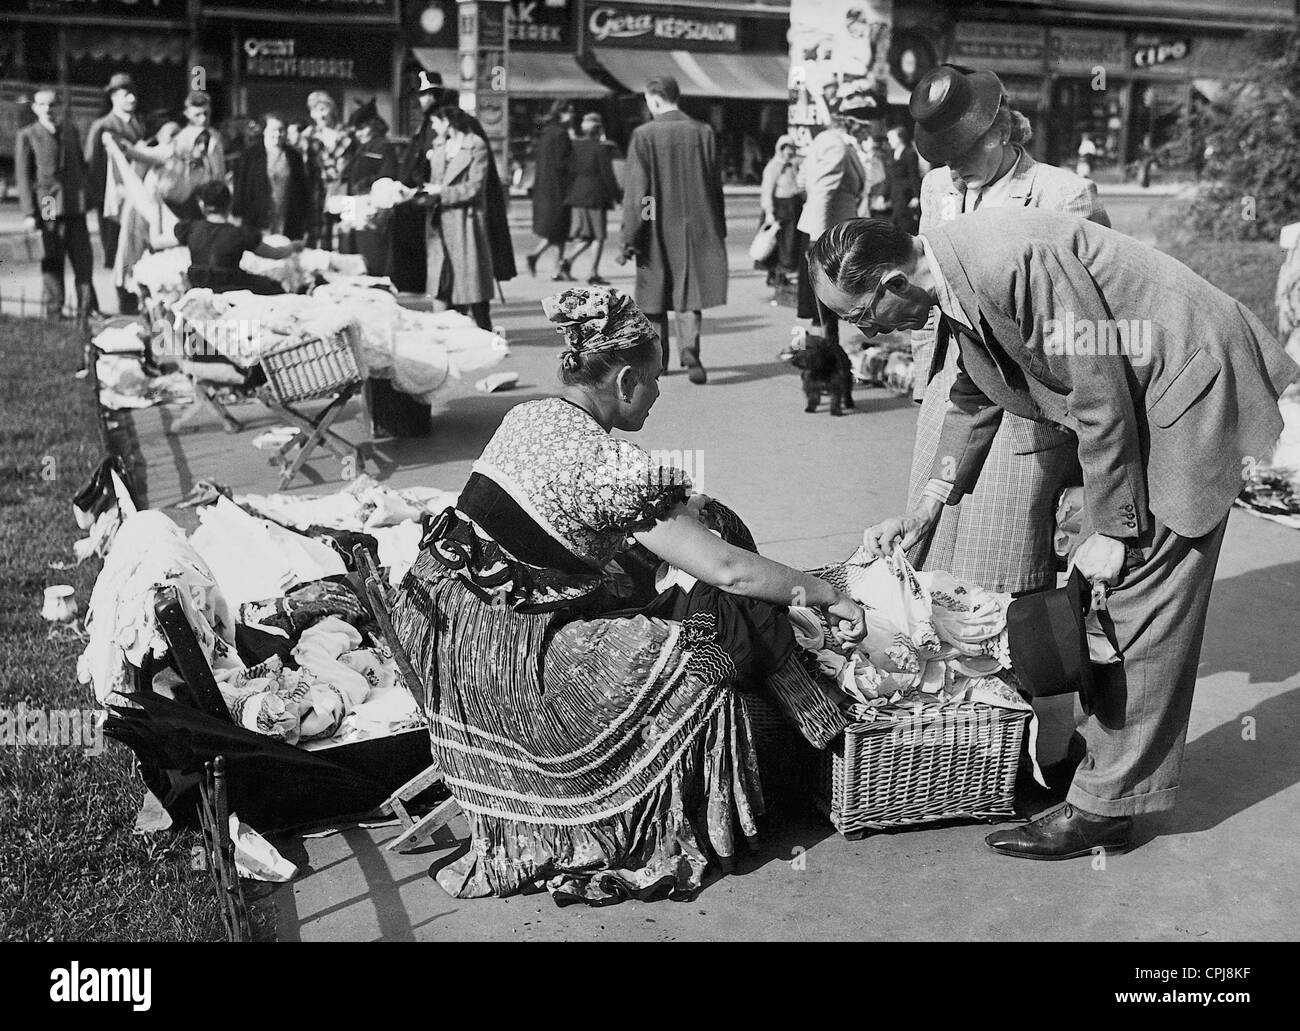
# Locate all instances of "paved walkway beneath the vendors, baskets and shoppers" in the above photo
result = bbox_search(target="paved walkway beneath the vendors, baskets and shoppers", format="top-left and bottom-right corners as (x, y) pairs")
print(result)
(40, 188), (1300, 941)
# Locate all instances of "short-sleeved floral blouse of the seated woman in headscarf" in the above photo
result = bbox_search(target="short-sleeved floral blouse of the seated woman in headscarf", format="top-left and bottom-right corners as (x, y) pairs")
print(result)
(473, 398), (692, 568)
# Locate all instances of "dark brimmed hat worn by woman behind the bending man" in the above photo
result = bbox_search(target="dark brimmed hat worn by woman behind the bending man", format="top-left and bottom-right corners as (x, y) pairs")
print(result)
(907, 65), (1006, 165)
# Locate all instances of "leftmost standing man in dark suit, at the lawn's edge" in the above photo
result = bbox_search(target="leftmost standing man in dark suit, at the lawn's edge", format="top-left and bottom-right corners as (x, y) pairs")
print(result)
(14, 90), (96, 319)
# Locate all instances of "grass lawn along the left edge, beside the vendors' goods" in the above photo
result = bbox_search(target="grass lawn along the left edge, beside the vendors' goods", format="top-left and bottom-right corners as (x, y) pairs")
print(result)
(0, 316), (224, 941)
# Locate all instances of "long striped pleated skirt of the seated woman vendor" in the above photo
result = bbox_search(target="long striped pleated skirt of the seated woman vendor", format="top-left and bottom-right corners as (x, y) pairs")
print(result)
(394, 554), (763, 904)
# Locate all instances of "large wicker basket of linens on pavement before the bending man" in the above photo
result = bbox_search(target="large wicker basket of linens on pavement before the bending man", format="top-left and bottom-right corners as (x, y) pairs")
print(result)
(820, 702), (1031, 837)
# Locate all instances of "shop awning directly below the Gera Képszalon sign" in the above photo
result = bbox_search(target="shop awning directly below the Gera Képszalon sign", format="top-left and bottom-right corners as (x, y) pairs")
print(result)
(595, 47), (790, 100)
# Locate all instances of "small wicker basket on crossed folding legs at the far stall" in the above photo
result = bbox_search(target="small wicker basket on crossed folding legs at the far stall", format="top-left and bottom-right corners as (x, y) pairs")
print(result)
(259, 337), (365, 490)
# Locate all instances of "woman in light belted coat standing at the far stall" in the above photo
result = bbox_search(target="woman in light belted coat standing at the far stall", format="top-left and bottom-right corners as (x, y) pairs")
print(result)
(424, 107), (497, 330)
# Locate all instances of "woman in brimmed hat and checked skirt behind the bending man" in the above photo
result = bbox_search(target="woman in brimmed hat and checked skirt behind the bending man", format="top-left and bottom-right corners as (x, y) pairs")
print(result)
(907, 65), (1110, 594)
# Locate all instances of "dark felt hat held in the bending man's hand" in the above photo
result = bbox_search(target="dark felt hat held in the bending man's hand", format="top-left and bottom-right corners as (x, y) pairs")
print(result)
(1006, 568), (1096, 712)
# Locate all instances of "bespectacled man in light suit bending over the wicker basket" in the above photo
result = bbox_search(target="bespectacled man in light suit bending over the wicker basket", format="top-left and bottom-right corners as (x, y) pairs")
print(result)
(809, 209), (1300, 859)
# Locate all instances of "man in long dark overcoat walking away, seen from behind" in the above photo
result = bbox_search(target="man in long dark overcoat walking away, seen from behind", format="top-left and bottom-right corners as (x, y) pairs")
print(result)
(621, 75), (727, 384)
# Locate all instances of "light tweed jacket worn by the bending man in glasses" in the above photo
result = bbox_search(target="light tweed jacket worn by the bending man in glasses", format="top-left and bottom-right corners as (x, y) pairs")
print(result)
(926, 208), (1300, 538)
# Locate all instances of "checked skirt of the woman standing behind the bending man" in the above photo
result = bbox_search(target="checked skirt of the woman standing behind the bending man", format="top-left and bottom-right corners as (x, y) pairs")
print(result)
(907, 346), (1083, 594)
